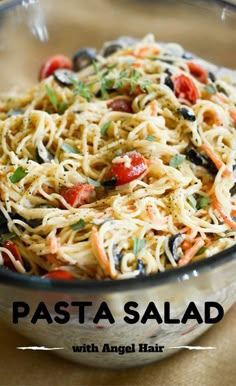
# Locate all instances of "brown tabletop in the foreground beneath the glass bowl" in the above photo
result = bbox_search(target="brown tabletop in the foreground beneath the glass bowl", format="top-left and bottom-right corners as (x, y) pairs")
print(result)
(0, 306), (236, 386)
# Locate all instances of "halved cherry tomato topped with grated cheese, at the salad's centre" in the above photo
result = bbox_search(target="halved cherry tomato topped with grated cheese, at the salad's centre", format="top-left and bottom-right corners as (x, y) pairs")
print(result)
(108, 151), (147, 186)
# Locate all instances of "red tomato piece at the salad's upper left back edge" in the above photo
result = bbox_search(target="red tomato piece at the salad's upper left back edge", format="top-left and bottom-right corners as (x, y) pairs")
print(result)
(39, 55), (72, 80)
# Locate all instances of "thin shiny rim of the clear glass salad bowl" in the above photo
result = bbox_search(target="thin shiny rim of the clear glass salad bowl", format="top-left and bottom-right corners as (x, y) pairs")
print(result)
(0, 0), (236, 294)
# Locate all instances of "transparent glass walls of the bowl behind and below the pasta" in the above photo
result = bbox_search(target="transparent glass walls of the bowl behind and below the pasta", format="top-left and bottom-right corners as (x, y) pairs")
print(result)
(0, 0), (236, 368)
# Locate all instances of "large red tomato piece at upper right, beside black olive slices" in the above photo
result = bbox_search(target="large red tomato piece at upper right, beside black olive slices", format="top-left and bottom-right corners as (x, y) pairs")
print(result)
(172, 74), (199, 104)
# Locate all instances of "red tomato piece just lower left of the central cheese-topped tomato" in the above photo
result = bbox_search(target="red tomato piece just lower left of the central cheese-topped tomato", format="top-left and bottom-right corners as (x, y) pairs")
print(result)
(61, 184), (94, 208)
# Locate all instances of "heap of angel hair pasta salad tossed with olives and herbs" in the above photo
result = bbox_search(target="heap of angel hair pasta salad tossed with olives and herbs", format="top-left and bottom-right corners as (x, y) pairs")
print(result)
(0, 35), (236, 279)
